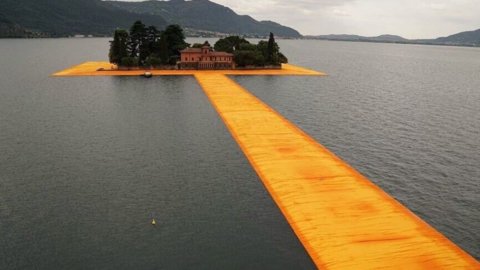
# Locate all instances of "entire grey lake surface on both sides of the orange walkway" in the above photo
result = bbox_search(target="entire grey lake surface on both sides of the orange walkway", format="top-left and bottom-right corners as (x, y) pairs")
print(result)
(0, 39), (480, 269)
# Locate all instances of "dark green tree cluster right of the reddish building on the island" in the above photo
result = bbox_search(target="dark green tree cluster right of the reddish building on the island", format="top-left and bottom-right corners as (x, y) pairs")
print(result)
(214, 33), (288, 67)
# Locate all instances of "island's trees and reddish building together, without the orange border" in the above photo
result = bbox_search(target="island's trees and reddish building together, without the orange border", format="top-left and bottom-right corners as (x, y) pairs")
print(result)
(109, 21), (288, 70)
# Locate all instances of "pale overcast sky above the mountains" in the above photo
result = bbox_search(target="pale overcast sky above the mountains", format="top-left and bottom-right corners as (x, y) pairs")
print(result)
(124, 0), (480, 38)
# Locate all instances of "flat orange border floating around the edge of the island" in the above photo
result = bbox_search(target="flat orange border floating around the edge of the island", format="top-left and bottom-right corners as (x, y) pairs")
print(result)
(53, 62), (325, 77)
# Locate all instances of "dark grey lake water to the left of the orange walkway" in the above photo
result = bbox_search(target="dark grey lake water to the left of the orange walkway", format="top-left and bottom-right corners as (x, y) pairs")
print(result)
(0, 39), (314, 270)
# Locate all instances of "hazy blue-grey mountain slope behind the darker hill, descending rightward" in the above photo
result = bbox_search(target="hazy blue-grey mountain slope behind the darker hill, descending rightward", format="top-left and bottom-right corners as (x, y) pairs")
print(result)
(107, 0), (301, 38)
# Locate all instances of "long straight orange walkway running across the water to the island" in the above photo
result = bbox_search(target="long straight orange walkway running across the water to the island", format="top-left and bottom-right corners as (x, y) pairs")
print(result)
(195, 73), (480, 270)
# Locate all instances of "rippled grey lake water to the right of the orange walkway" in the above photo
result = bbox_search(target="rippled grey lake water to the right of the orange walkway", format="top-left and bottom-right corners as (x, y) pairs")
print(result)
(236, 41), (480, 259)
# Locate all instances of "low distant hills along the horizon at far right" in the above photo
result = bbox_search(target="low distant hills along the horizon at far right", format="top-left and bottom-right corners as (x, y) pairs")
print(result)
(304, 29), (480, 46)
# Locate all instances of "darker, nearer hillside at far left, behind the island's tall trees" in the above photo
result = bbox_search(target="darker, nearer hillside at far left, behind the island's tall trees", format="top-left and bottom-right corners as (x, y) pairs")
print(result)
(0, 0), (166, 37)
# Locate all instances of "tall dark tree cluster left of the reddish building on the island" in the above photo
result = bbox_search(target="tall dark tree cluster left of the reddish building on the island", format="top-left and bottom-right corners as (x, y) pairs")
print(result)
(109, 21), (189, 67)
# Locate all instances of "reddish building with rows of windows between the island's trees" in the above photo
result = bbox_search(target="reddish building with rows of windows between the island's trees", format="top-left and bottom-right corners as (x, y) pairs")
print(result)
(179, 41), (235, 69)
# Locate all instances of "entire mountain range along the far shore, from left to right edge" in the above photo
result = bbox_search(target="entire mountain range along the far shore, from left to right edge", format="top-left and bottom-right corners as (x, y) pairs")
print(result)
(0, 0), (480, 46)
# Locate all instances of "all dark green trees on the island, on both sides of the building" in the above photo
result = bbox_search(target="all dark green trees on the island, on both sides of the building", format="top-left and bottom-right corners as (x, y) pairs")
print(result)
(109, 24), (288, 67)
